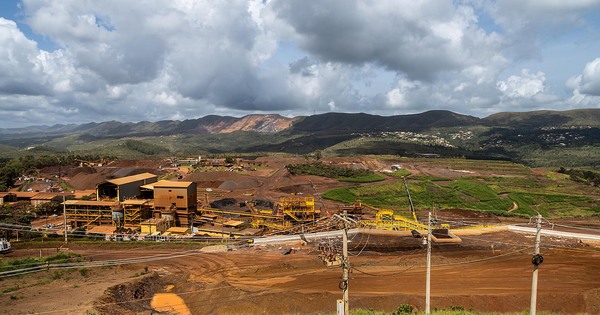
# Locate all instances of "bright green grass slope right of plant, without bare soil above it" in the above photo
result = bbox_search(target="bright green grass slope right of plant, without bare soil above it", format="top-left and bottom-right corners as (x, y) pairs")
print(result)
(323, 175), (600, 218)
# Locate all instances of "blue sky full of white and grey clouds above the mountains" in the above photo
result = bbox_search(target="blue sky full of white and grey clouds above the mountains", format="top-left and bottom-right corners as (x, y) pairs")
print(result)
(0, 0), (600, 128)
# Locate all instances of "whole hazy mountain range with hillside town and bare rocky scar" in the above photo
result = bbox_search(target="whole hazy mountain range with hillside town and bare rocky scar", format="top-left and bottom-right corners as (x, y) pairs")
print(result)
(0, 109), (600, 168)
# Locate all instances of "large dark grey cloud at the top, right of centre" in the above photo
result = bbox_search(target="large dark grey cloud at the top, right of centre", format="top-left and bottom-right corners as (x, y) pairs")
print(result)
(273, 0), (476, 79)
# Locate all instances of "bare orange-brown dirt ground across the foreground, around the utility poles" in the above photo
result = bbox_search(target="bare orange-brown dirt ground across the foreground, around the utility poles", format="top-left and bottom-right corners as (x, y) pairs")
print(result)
(0, 232), (600, 314)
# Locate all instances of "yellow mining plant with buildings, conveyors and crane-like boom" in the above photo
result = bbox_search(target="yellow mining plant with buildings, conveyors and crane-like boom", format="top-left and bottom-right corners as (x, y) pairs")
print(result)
(18, 157), (459, 240)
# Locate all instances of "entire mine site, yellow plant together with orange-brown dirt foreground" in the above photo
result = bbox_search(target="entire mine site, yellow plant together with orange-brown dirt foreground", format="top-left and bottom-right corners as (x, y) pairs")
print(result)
(0, 157), (600, 314)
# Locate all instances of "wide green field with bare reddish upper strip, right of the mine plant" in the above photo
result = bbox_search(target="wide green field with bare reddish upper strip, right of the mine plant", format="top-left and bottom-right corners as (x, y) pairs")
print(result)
(323, 160), (600, 218)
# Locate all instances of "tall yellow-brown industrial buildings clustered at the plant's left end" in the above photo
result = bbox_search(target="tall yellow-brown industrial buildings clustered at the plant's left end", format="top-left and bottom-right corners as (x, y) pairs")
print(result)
(62, 173), (197, 234)
